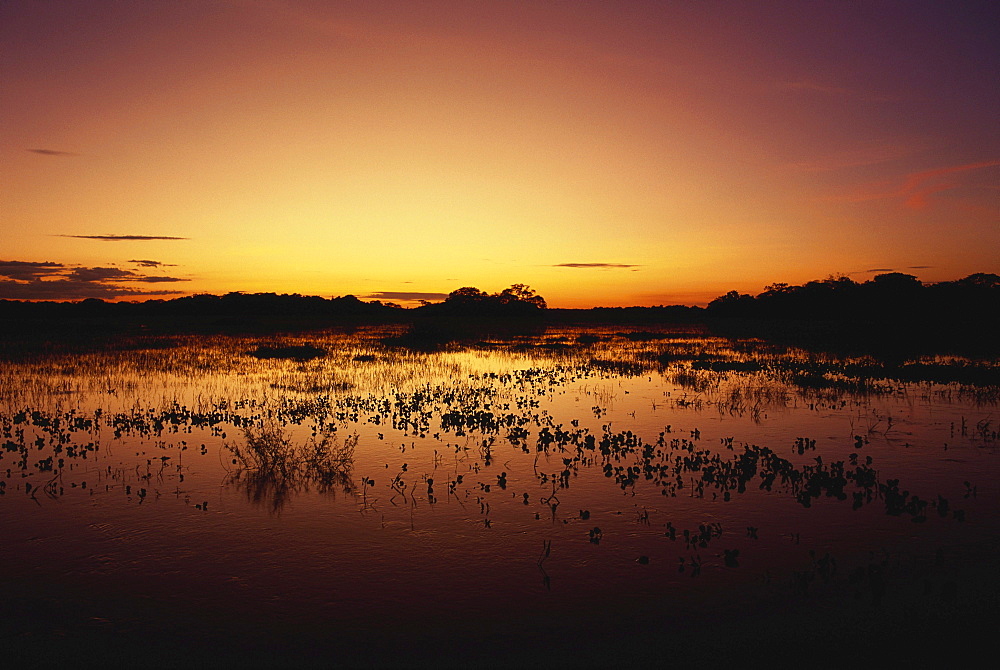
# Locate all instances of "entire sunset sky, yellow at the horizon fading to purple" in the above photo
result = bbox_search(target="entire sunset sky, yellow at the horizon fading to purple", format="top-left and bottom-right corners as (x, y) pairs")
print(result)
(0, 0), (1000, 307)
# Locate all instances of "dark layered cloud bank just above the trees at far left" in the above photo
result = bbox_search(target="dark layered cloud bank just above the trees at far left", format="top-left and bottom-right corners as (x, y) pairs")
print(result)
(0, 261), (190, 300)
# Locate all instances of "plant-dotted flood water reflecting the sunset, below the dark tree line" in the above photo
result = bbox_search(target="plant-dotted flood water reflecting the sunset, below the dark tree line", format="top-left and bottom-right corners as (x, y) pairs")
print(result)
(0, 327), (1000, 666)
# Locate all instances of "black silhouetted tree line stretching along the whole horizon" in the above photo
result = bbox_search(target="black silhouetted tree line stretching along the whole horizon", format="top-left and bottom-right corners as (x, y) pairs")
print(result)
(0, 272), (1000, 323)
